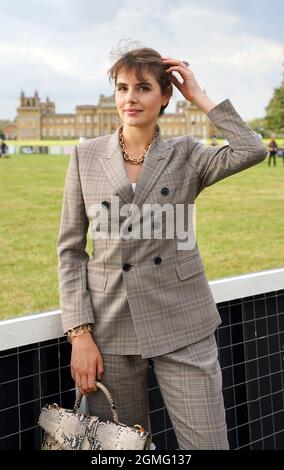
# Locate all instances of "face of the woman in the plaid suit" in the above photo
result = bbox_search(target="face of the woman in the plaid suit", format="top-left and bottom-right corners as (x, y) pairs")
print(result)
(115, 70), (169, 127)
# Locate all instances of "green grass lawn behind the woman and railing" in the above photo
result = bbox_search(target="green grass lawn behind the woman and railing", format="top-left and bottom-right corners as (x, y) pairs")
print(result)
(0, 155), (284, 319)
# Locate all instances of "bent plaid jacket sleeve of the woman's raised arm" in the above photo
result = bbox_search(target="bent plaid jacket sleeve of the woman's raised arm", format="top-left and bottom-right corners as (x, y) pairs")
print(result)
(187, 99), (267, 194)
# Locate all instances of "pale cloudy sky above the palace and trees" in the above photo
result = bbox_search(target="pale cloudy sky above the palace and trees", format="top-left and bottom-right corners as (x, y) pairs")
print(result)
(0, 0), (284, 120)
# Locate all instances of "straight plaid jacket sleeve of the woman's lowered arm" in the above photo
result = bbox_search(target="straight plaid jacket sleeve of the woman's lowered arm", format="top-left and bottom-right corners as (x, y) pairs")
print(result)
(57, 146), (94, 334)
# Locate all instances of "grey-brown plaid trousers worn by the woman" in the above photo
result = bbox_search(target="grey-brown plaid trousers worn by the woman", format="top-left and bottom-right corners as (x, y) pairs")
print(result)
(87, 334), (229, 450)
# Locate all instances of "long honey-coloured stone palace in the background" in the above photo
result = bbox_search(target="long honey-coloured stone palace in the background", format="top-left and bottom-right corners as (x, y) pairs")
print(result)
(5, 91), (218, 140)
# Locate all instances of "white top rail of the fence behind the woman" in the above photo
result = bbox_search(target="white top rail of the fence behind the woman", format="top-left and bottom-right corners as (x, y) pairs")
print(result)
(0, 268), (284, 351)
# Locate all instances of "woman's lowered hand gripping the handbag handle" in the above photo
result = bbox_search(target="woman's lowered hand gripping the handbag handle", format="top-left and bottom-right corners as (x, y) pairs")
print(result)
(71, 332), (104, 395)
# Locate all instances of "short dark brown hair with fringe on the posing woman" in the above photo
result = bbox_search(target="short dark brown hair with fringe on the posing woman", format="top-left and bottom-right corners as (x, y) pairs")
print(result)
(107, 39), (173, 117)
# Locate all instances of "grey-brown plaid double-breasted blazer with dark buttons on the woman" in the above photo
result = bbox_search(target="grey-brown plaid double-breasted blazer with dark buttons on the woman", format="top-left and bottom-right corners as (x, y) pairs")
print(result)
(57, 99), (267, 358)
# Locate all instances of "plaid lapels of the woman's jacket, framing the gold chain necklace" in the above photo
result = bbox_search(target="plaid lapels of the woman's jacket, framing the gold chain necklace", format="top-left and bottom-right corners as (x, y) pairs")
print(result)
(99, 126), (174, 207)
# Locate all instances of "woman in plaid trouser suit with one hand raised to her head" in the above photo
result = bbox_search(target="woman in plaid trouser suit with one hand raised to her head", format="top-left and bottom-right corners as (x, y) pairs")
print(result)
(58, 48), (266, 449)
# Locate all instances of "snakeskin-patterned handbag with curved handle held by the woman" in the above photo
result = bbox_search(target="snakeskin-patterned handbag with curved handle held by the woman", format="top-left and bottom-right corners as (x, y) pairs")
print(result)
(38, 382), (151, 450)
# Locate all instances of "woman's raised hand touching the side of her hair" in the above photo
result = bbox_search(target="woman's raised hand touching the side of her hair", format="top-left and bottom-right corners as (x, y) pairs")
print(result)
(162, 57), (204, 103)
